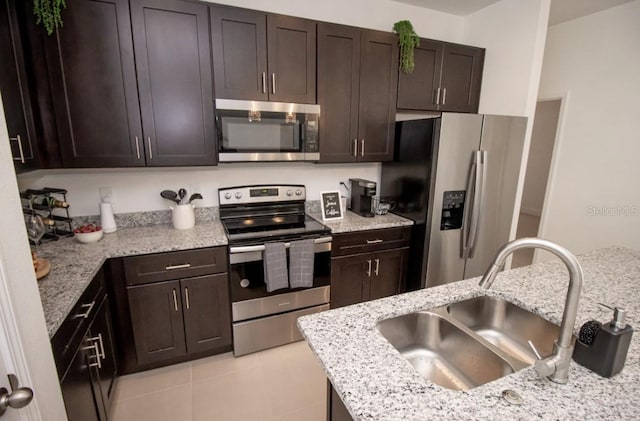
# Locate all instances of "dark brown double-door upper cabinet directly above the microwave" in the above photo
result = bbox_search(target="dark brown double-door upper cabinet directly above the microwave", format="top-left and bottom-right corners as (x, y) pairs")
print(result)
(211, 6), (316, 104)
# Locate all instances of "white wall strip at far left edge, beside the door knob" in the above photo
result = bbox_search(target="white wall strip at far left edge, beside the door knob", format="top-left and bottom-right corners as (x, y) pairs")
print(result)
(0, 92), (66, 421)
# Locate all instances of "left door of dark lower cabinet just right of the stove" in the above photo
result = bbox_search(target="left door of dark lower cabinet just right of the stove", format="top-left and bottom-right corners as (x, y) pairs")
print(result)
(331, 254), (364, 308)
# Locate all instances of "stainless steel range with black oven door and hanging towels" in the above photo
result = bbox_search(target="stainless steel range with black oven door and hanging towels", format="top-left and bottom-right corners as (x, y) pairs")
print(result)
(218, 185), (331, 356)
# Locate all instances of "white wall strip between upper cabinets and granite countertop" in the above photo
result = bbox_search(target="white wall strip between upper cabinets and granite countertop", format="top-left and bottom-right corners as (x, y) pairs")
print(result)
(19, 163), (380, 216)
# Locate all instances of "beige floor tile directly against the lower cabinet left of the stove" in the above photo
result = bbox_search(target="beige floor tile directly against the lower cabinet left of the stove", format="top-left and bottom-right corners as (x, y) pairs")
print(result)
(116, 362), (191, 400)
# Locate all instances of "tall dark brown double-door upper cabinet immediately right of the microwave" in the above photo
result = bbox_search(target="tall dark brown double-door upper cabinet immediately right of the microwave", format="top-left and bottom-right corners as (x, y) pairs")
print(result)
(318, 24), (398, 162)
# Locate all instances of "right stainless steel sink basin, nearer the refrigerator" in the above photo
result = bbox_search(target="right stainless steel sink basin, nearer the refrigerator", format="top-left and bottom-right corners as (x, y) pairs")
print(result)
(446, 296), (560, 366)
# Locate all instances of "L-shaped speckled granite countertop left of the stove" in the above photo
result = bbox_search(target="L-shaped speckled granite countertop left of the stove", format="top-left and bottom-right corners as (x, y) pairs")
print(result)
(38, 221), (227, 337)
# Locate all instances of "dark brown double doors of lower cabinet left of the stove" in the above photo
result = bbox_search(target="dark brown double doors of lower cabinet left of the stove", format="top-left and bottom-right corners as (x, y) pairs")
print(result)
(127, 273), (231, 366)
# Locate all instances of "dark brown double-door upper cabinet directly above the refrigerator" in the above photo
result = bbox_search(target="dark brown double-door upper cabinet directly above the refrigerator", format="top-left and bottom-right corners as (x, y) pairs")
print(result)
(397, 39), (484, 113)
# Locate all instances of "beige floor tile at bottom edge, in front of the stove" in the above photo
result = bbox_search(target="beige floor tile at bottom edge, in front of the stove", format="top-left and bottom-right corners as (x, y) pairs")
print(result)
(193, 367), (274, 421)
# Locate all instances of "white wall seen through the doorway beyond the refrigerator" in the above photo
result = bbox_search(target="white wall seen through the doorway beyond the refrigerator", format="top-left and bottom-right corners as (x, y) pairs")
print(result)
(520, 99), (560, 216)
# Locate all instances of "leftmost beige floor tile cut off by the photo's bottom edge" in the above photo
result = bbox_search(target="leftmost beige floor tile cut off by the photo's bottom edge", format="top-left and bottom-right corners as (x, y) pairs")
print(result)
(110, 384), (191, 421)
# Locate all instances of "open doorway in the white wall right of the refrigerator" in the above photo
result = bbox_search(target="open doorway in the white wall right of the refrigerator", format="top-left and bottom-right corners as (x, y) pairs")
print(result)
(511, 98), (562, 268)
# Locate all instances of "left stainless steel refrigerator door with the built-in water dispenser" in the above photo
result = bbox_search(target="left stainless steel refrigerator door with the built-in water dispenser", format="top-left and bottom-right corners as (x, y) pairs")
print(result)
(425, 113), (482, 287)
